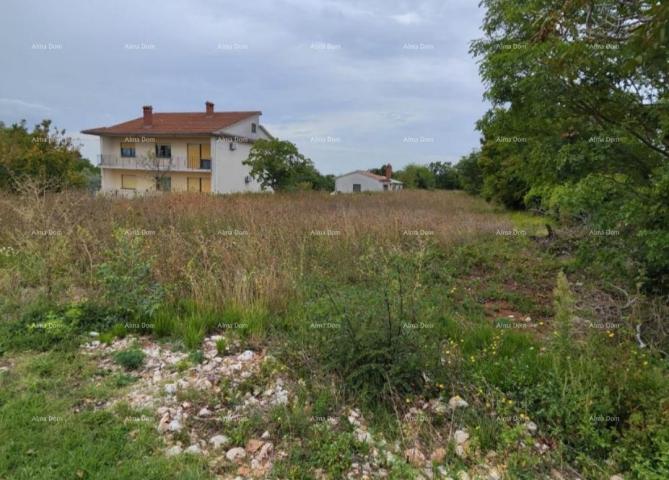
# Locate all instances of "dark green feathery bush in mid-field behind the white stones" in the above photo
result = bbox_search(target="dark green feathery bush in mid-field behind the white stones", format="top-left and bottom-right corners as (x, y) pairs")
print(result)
(291, 248), (441, 406)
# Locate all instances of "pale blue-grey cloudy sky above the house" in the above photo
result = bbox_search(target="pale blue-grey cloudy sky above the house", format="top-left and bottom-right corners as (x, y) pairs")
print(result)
(0, 0), (486, 173)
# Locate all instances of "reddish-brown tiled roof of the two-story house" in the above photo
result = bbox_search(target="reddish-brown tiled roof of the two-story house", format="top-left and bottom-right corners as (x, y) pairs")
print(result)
(81, 112), (262, 136)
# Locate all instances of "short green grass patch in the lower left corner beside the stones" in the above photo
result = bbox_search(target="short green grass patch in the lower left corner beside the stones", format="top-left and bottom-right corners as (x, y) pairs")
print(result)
(0, 352), (213, 480)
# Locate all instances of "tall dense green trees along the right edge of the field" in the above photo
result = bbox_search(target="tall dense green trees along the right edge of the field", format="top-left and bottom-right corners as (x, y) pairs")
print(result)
(458, 0), (669, 291)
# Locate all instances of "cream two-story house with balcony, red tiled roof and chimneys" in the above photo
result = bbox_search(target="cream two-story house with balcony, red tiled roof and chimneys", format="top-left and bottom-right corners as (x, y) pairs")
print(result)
(81, 102), (272, 196)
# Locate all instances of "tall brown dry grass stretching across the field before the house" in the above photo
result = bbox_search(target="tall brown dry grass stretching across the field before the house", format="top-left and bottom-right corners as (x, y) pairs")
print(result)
(0, 191), (510, 307)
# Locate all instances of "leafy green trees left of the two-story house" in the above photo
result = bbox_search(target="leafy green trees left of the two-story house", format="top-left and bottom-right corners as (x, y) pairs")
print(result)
(0, 120), (98, 191)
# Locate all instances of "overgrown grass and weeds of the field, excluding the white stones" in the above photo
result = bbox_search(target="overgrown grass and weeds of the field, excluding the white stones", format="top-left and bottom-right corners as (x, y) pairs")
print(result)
(0, 192), (669, 479)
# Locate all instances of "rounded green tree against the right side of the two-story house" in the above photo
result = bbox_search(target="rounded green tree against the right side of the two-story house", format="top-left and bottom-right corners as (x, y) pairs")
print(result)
(244, 139), (334, 191)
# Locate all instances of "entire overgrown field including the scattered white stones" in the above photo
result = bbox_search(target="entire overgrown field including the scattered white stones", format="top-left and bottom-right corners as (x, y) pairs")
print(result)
(0, 191), (669, 480)
